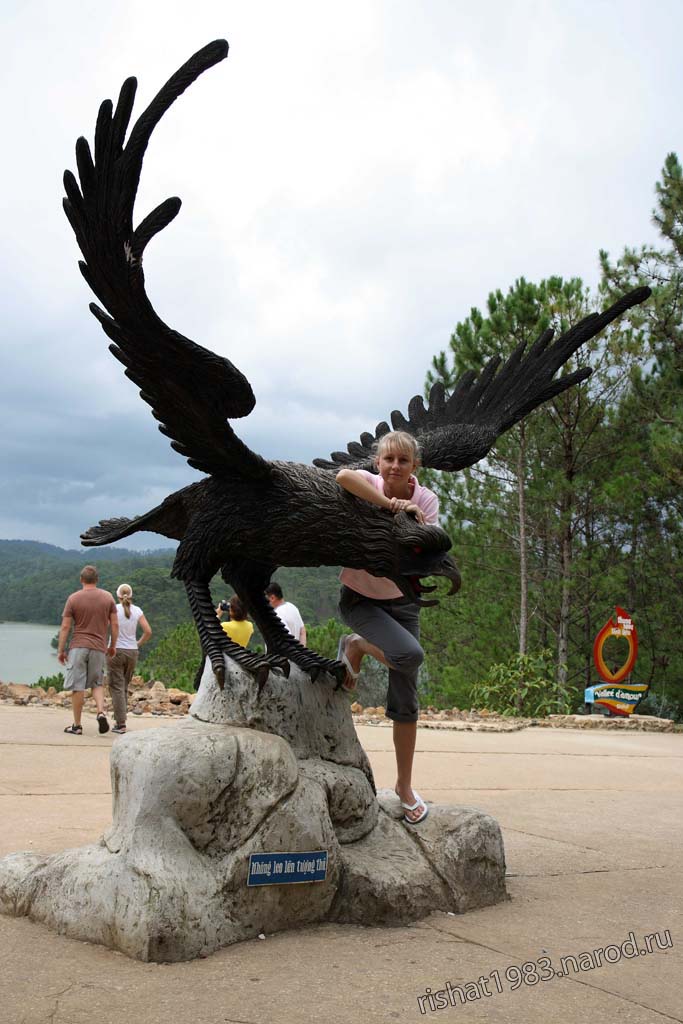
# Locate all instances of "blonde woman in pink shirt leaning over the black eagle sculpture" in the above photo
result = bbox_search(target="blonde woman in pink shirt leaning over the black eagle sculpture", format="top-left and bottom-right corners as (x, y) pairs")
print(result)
(337, 430), (438, 824)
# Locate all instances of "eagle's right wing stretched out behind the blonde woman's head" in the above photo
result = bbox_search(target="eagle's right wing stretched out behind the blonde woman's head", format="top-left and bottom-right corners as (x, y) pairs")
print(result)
(313, 288), (650, 472)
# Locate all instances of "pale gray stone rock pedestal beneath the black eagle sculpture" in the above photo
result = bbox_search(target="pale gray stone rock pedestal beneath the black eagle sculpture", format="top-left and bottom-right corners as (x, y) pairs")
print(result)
(0, 662), (506, 962)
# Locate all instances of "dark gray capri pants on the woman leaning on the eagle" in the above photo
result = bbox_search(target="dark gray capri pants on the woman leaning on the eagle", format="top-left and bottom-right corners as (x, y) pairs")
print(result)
(339, 587), (425, 722)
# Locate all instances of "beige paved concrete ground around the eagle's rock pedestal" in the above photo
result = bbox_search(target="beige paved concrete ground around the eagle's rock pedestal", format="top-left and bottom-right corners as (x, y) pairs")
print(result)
(0, 706), (683, 1024)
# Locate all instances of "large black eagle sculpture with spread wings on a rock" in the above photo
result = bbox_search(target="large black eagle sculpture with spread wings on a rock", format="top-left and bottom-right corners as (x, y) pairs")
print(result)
(63, 40), (649, 687)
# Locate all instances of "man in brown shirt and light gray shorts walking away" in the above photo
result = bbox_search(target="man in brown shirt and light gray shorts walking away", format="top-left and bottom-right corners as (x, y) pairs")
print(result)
(57, 565), (119, 736)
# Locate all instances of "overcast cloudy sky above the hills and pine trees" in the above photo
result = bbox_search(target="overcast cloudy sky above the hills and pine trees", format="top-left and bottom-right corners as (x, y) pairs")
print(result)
(0, 0), (683, 548)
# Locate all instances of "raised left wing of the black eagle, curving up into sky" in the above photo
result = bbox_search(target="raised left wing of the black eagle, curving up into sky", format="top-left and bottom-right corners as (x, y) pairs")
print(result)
(63, 40), (270, 477)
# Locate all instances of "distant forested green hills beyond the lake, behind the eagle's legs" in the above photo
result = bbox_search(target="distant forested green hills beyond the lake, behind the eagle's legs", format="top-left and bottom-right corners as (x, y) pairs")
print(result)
(0, 541), (339, 649)
